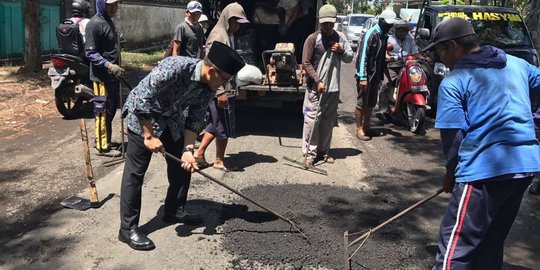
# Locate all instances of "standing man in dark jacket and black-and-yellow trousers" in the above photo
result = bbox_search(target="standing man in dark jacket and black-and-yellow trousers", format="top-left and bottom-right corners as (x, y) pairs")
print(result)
(85, 0), (125, 156)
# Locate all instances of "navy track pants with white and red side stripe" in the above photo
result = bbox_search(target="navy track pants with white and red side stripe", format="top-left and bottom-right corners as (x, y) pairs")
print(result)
(433, 177), (533, 270)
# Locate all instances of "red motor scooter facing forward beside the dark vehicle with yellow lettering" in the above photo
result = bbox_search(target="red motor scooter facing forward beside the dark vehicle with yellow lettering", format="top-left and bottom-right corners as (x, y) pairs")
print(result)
(387, 44), (430, 134)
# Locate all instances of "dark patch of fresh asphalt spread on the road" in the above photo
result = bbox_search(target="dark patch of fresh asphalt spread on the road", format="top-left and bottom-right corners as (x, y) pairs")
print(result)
(222, 185), (431, 269)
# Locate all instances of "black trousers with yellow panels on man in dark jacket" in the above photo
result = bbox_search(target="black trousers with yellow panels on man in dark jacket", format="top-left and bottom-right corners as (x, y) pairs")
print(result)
(93, 79), (120, 151)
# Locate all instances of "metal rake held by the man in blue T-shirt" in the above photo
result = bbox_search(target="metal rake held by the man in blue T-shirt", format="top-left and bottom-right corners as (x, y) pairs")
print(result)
(343, 188), (443, 270)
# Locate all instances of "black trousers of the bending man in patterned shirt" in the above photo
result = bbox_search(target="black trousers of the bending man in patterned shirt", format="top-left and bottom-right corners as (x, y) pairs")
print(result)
(120, 129), (191, 230)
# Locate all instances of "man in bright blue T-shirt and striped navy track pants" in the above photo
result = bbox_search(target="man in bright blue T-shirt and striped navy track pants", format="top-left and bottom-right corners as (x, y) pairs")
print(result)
(425, 18), (540, 269)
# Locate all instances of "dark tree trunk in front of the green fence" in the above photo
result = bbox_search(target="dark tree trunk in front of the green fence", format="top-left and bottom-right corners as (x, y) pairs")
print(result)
(24, 0), (41, 72)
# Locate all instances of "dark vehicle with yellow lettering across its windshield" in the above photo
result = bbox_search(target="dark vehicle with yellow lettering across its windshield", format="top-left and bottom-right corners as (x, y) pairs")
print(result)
(415, 5), (539, 111)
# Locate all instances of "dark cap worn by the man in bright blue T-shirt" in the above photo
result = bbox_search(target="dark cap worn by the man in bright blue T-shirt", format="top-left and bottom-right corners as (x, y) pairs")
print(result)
(422, 17), (476, 52)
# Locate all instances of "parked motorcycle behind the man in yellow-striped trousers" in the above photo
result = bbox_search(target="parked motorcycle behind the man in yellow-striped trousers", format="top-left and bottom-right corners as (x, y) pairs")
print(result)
(47, 54), (94, 118)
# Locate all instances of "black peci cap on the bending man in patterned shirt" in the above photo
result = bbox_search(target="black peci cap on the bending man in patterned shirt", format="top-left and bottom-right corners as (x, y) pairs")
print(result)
(207, 41), (246, 75)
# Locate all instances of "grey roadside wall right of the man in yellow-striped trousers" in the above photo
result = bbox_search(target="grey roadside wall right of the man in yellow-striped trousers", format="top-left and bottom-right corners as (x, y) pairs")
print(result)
(114, 3), (184, 50)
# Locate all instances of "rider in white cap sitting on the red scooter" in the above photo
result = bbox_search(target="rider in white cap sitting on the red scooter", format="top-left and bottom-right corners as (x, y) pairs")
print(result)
(375, 20), (421, 118)
